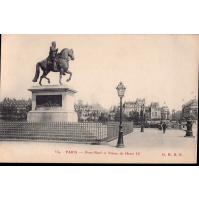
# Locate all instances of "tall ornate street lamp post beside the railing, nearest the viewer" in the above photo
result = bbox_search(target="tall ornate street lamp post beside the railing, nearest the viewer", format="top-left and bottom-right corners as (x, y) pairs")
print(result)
(116, 82), (126, 148)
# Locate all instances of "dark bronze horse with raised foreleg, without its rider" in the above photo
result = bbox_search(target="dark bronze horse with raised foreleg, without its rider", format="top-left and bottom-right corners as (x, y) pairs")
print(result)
(32, 48), (75, 85)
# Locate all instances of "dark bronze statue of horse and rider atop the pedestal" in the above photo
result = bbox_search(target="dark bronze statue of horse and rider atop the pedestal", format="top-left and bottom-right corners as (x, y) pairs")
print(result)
(32, 41), (75, 85)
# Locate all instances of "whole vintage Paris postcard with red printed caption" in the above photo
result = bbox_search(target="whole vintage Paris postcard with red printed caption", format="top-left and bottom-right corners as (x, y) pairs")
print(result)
(0, 34), (199, 164)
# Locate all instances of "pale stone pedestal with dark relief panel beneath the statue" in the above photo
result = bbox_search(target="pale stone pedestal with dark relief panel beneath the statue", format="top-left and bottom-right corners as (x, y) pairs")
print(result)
(27, 85), (78, 123)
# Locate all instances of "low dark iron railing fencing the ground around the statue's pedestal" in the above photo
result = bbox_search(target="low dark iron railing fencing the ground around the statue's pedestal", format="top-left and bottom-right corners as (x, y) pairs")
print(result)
(0, 122), (133, 142)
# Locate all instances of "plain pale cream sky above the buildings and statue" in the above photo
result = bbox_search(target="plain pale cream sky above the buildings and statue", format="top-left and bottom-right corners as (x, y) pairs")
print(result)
(0, 34), (199, 111)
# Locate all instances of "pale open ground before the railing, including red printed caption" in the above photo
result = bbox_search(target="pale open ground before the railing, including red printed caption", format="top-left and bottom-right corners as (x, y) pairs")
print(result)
(0, 128), (197, 163)
